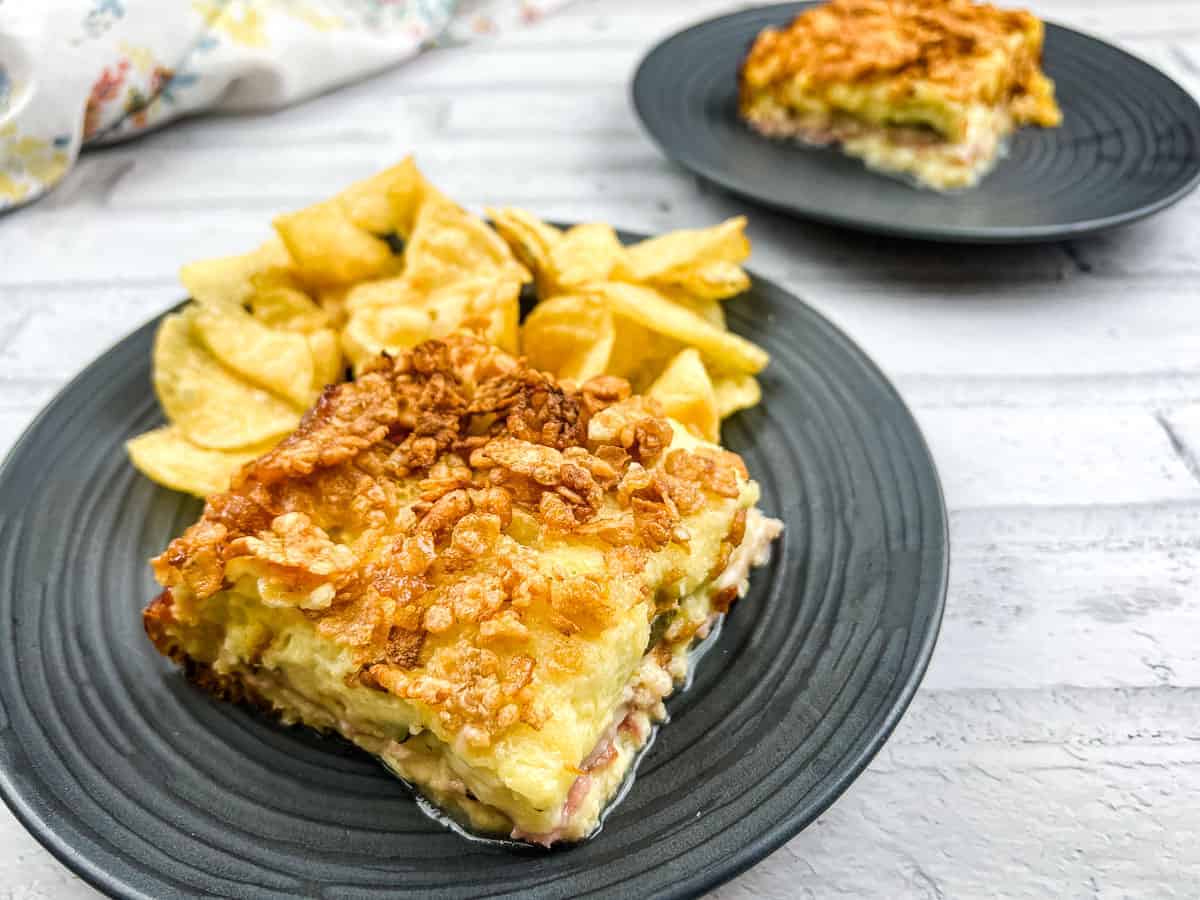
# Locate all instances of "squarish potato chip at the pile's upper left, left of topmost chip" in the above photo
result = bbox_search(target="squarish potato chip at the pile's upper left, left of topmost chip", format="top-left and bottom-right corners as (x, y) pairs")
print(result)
(275, 200), (397, 287)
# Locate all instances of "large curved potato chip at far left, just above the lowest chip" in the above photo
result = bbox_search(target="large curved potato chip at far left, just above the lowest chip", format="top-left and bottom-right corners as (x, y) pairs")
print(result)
(154, 306), (300, 450)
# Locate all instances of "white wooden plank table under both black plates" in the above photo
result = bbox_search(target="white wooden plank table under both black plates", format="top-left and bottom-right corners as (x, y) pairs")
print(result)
(0, 0), (1200, 900)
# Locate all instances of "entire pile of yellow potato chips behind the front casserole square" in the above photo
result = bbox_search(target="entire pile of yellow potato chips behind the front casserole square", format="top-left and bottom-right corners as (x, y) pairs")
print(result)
(127, 160), (768, 497)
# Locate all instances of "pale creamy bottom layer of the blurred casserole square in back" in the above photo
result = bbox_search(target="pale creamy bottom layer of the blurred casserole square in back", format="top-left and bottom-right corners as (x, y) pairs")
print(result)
(745, 101), (1013, 191)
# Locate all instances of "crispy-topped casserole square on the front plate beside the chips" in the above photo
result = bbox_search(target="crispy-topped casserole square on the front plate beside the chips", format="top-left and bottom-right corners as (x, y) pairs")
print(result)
(144, 335), (781, 845)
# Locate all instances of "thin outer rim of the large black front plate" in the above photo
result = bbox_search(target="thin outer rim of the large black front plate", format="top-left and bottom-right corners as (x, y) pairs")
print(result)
(0, 250), (952, 900)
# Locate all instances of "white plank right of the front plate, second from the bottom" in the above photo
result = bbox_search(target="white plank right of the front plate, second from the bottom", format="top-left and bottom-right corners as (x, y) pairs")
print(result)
(924, 542), (1200, 690)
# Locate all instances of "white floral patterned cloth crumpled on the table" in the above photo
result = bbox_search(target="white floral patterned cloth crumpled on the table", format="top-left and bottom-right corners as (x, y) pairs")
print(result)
(0, 0), (569, 210)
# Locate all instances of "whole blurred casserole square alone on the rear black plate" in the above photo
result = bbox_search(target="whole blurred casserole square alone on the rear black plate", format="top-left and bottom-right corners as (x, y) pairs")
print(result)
(739, 0), (1062, 190)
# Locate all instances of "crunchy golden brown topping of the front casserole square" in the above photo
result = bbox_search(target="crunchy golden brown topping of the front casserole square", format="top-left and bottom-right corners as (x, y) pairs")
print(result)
(145, 335), (745, 746)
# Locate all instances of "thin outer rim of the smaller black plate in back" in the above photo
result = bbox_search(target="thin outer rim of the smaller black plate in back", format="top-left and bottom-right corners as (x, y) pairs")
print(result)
(628, 0), (1200, 245)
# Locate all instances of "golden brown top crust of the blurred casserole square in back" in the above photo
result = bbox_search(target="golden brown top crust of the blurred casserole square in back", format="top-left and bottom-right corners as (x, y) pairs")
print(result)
(742, 0), (1060, 125)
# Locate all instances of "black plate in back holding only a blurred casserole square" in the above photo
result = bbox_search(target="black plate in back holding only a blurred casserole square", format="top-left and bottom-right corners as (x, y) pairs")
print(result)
(634, 4), (1200, 244)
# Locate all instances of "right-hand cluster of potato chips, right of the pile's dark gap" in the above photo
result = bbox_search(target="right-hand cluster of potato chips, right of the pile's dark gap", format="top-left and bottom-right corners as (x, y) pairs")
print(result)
(488, 209), (768, 442)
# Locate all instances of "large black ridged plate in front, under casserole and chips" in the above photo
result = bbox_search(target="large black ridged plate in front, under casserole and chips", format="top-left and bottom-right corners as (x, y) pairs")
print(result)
(0, 256), (947, 900)
